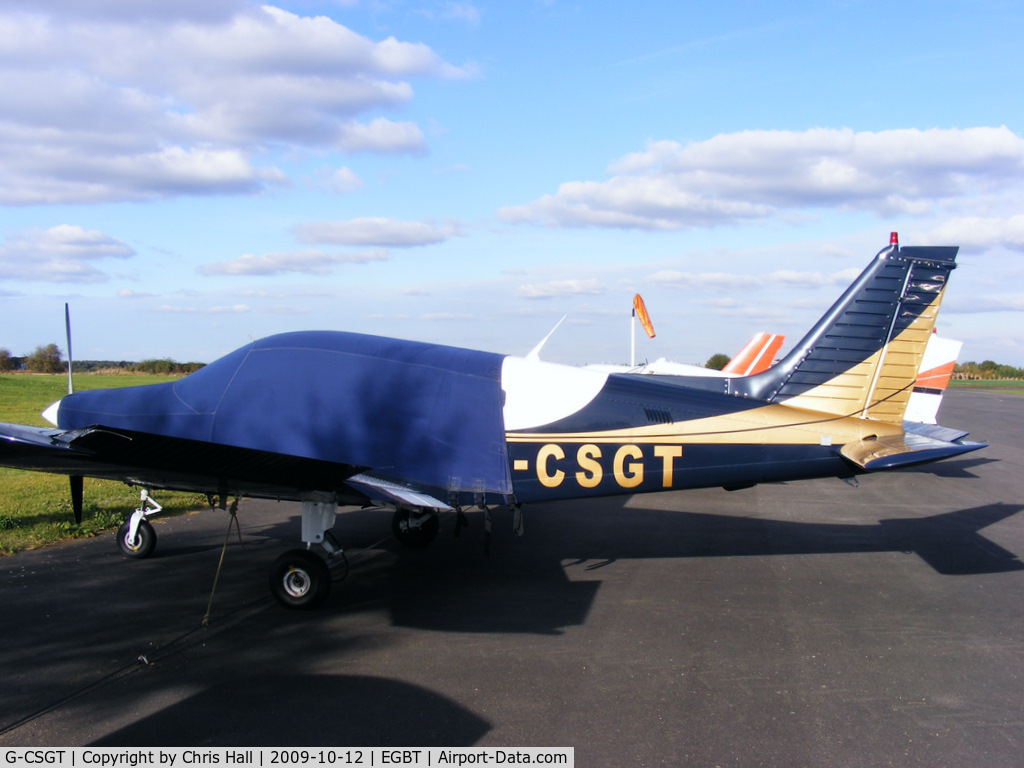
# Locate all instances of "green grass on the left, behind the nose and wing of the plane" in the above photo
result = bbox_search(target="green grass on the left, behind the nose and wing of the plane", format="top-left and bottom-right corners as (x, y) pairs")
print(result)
(0, 374), (206, 555)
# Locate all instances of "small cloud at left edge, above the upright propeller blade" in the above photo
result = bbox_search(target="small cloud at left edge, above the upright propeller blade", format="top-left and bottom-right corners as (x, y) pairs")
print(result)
(0, 224), (135, 283)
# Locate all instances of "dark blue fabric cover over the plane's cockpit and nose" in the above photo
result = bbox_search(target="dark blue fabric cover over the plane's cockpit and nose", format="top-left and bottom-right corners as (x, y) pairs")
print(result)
(58, 331), (512, 495)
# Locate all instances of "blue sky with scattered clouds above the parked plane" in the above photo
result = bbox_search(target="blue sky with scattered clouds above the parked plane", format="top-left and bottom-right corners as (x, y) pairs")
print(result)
(0, 0), (1024, 366)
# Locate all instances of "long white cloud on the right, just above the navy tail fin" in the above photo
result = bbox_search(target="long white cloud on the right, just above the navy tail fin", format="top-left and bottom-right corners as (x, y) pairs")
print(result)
(499, 127), (1024, 229)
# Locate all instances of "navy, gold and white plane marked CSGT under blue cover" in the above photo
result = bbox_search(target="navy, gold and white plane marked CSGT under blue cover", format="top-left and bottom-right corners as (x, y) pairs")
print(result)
(0, 233), (984, 608)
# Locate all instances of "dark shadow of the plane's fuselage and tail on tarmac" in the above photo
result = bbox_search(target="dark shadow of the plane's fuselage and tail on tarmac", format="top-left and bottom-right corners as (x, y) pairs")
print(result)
(251, 500), (1024, 634)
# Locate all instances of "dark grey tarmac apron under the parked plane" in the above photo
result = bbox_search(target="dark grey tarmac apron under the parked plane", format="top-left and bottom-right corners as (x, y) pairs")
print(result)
(0, 390), (1024, 768)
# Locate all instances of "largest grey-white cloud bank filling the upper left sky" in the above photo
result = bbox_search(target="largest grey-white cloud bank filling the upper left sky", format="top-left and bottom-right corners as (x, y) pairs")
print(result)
(0, 0), (471, 205)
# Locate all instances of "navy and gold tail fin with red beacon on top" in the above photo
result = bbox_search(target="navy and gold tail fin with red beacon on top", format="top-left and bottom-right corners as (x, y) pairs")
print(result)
(726, 232), (958, 424)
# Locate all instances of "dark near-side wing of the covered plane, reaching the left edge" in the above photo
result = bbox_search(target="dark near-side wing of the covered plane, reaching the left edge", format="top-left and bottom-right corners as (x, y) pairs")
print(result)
(0, 423), (374, 503)
